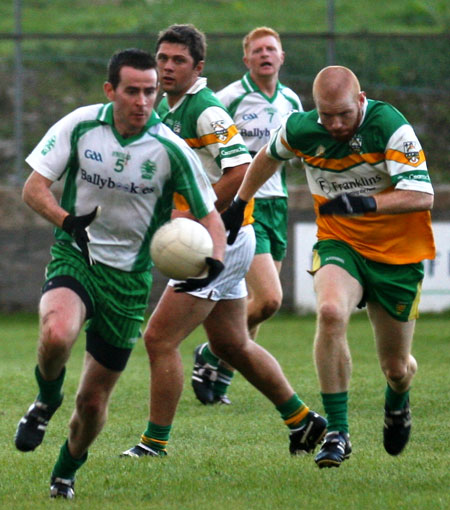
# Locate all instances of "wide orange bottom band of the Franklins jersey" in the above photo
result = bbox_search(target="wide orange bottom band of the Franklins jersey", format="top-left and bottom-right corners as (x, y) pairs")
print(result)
(313, 188), (435, 265)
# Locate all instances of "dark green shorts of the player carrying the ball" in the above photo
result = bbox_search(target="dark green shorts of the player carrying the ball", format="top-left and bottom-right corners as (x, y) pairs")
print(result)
(44, 242), (152, 349)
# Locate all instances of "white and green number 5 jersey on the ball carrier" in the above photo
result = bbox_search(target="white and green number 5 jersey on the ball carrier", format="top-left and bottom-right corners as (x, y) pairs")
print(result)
(26, 103), (216, 271)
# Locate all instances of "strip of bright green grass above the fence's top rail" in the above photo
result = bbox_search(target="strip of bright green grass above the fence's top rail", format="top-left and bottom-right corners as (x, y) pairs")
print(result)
(0, 0), (450, 33)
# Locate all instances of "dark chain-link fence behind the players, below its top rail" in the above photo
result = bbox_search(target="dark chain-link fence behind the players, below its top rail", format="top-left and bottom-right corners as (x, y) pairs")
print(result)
(0, 33), (450, 185)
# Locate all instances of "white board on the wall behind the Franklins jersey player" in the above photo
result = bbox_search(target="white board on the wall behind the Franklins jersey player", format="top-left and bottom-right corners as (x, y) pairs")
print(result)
(293, 222), (450, 313)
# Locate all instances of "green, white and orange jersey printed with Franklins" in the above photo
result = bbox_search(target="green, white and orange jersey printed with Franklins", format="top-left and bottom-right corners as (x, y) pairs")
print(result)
(267, 100), (435, 264)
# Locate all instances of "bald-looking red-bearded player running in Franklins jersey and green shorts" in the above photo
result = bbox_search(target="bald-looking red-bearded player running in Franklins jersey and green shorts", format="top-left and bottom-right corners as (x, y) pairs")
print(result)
(225, 66), (435, 468)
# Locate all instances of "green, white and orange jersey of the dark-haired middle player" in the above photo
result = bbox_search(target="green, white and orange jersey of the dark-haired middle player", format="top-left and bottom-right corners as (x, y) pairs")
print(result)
(157, 78), (251, 184)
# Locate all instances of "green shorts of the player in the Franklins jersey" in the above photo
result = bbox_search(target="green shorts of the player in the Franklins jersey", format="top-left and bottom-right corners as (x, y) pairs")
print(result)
(313, 239), (424, 322)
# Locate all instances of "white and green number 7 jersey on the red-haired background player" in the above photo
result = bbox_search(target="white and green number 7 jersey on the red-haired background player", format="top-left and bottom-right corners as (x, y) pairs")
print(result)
(217, 72), (303, 198)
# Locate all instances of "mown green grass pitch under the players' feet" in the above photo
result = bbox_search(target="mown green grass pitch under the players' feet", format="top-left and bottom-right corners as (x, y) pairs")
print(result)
(0, 313), (450, 510)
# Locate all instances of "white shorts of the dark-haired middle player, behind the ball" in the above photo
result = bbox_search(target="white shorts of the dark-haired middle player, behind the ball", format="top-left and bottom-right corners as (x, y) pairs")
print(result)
(168, 225), (256, 301)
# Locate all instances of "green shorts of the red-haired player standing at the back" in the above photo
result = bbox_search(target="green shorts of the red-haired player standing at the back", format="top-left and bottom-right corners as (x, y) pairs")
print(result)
(253, 197), (288, 261)
